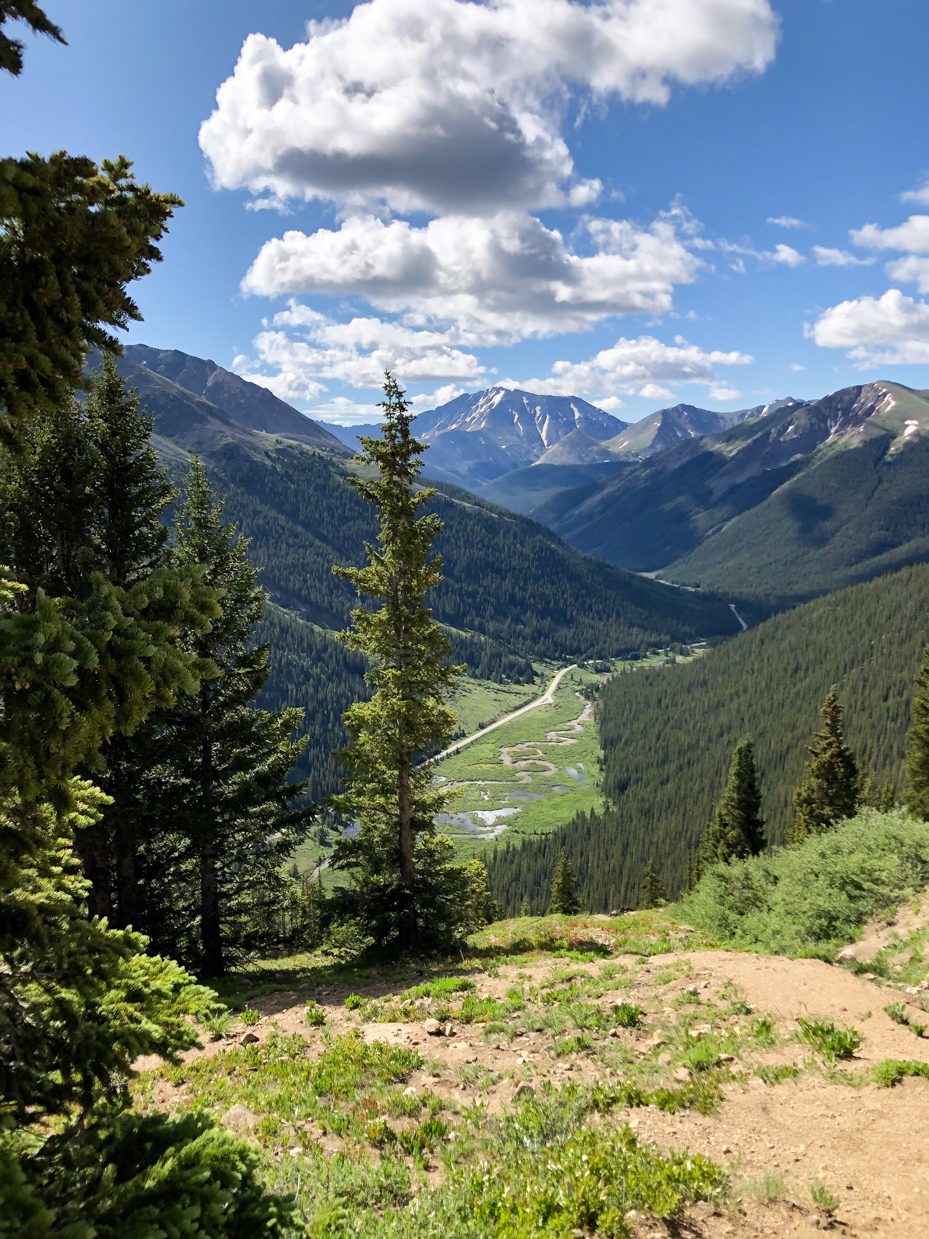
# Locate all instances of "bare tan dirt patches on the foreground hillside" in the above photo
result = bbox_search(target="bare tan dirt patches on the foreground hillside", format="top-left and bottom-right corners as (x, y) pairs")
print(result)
(136, 930), (929, 1239)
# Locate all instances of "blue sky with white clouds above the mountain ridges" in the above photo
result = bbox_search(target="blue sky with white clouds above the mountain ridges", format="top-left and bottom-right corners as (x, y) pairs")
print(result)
(0, 0), (929, 421)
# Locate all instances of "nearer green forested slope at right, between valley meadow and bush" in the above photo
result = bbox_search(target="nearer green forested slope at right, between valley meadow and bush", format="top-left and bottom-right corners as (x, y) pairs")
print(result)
(491, 565), (929, 911)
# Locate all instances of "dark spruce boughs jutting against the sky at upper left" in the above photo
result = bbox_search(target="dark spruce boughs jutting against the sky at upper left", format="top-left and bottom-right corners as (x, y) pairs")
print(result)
(0, 150), (181, 446)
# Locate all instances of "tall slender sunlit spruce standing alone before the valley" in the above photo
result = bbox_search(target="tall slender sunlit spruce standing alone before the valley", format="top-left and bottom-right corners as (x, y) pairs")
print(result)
(333, 374), (463, 947)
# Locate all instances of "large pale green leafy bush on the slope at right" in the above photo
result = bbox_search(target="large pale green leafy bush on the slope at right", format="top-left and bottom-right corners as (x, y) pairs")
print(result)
(676, 809), (929, 958)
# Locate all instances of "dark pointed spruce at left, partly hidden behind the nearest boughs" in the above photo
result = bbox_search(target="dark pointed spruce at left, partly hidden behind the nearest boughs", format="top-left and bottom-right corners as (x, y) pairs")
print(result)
(10, 357), (219, 928)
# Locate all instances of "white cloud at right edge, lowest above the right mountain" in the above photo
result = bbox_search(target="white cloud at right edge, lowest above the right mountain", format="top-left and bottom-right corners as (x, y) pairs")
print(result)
(806, 289), (929, 369)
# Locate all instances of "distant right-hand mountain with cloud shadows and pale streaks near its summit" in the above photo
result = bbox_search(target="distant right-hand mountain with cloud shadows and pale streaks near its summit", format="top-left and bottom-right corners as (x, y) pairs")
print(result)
(534, 383), (929, 605)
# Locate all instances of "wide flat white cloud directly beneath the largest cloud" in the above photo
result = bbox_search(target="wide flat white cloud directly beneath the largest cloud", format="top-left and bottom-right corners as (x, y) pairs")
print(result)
(243, 212), (702, 346)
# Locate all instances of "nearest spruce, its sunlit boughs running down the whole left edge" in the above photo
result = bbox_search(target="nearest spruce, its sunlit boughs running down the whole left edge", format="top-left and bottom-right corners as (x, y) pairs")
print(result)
(0, 19), (294, 1239)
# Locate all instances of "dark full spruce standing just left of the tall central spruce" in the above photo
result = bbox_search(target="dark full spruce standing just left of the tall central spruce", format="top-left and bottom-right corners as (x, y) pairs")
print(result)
(141, 460), (311, 976)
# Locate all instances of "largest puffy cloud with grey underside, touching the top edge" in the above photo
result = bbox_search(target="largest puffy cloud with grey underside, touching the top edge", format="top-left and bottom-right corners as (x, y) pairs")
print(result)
(199, 0), (779, 214)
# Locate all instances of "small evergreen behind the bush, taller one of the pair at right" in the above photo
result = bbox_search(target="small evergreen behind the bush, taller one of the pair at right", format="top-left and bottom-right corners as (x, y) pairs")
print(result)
(788, 689), (861, 844)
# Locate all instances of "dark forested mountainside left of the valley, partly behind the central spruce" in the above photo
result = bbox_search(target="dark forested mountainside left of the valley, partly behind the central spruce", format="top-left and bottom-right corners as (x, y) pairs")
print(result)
(105, 354), (737, 794)
